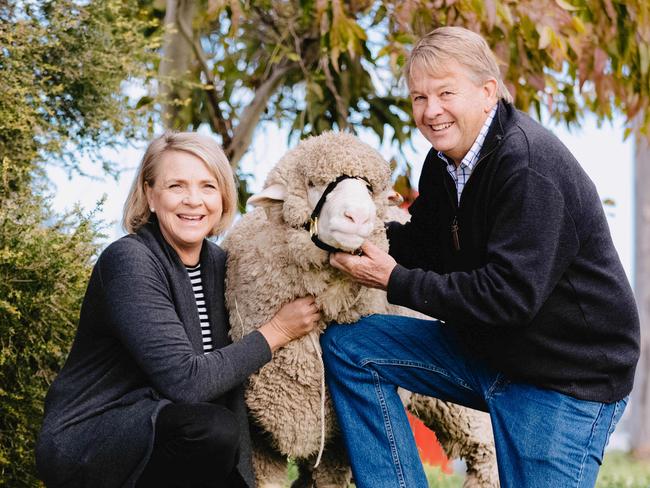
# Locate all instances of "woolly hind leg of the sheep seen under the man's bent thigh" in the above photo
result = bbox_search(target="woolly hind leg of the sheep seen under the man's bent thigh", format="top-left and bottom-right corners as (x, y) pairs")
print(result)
(408, 394), (499, 488)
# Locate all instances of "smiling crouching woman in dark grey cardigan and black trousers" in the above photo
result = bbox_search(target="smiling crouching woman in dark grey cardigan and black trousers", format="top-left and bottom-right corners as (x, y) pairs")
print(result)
(36, 133), (320, 488)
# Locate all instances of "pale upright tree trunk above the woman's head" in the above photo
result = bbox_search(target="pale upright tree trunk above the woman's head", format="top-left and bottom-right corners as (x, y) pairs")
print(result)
(158, 0), (196, 129)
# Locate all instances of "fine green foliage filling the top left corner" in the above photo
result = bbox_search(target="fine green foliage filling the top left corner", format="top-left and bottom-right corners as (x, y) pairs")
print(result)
(0, 0), (155, 185)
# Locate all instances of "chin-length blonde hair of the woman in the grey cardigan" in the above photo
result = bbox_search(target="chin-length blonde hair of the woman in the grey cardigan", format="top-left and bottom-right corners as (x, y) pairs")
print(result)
(122, 131), (237, 236)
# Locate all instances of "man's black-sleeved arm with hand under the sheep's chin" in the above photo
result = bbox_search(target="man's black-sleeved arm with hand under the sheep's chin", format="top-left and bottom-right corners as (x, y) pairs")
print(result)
(331, 168), (579, 326)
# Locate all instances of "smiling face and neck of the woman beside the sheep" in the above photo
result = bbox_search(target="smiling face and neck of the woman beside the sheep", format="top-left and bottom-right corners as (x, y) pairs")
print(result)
(145, 151), (223, 266)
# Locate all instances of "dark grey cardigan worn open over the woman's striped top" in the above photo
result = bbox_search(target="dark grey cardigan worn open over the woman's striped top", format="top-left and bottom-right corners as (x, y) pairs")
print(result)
(36, 219), (271, 488)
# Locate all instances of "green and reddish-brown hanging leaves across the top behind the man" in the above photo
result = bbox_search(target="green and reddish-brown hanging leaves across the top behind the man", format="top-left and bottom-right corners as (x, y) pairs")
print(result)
(163, 0), (650, 152)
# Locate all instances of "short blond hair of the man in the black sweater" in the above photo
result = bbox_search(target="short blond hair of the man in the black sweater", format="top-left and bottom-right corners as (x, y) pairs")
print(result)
(404, 26), (512, 103)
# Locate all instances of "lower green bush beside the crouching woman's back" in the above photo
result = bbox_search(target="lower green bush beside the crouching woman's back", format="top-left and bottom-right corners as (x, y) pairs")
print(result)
(0, 186), (98, 488)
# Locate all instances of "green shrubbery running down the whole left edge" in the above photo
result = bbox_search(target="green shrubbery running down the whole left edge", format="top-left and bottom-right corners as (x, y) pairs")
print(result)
(0, 0), (154, 487)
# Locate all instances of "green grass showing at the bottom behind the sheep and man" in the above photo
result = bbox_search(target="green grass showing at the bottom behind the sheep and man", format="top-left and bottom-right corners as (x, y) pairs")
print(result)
(288, 451), (650, 488)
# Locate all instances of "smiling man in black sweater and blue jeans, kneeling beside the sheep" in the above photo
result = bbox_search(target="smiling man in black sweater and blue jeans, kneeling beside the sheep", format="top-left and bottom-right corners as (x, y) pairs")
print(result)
(322, 27), (639, 488)
